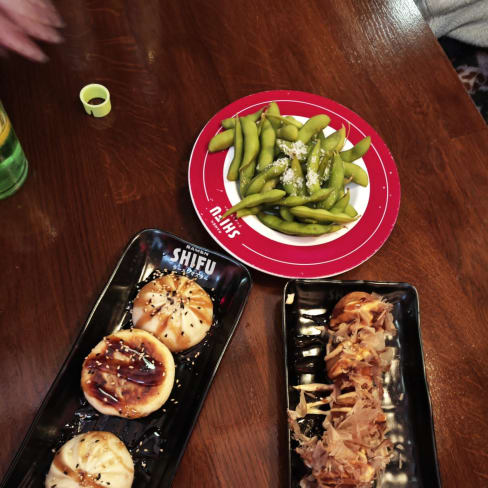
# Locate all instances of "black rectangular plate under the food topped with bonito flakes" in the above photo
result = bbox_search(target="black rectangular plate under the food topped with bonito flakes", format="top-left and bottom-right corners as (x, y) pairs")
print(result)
(283, 280), (441, 488)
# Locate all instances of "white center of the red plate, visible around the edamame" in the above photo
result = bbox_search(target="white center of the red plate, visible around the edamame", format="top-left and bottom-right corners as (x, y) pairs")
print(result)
(223, 115), (371, 246)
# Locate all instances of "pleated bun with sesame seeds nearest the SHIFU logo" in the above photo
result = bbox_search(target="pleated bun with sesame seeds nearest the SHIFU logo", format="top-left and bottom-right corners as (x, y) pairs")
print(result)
(132, 274), (213, 352)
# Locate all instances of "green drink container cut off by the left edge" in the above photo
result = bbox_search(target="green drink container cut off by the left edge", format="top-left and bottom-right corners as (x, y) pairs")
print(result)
(0, 102), (29, 199)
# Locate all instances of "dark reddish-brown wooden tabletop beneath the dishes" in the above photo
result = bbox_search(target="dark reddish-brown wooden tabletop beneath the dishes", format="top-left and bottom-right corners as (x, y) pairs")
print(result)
(0, 0), (488, 488)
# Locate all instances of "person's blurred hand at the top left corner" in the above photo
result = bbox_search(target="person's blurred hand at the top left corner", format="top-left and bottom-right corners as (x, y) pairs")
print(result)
(0, 0), (64, 61)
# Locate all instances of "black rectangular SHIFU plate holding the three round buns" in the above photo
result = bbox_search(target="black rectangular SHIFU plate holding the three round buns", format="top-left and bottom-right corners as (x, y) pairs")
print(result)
(1, 229), (251, 488)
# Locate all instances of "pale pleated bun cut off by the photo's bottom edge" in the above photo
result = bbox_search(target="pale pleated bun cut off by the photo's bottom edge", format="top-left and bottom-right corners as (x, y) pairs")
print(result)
(45, 432), (134, 488)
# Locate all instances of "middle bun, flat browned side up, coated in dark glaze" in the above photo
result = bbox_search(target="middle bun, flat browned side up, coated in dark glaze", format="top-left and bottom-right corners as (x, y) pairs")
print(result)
(81, 329), (175, 419)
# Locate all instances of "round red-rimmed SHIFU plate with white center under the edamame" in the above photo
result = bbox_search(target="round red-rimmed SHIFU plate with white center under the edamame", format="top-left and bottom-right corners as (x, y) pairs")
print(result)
(188, 90), (400, 278)
